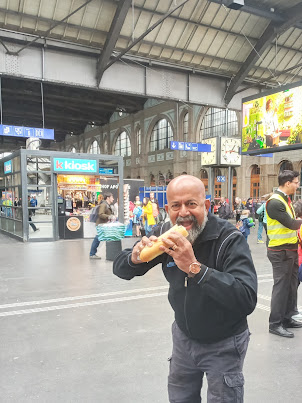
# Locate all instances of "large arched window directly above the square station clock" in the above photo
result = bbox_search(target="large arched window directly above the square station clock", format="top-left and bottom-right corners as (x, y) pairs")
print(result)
(199, 108), (238, 140)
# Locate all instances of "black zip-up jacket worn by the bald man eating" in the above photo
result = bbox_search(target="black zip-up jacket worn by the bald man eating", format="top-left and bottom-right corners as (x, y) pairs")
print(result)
(113, 213), (257, 343)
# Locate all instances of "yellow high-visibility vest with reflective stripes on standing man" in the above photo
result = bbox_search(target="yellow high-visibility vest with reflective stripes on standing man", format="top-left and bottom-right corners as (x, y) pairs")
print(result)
(266, 193), (298, 247)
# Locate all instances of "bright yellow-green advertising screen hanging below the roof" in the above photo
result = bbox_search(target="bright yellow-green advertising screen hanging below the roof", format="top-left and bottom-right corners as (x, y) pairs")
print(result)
(241, 82), (302, 155)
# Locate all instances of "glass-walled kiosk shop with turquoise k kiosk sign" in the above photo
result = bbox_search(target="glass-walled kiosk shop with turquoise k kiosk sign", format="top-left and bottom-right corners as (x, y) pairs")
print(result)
(0, 150), (124, 241)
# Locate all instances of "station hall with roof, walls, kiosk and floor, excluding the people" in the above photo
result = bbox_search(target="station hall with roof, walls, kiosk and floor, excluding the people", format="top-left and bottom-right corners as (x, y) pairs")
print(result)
(0, 0), (302, 403)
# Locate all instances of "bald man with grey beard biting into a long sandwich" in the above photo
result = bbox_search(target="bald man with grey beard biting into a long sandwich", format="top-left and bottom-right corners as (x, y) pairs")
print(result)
(113, 175), (257, 403)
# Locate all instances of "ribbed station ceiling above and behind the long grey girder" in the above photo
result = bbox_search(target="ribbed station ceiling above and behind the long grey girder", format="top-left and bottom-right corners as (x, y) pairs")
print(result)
(0, 0), (302, 147)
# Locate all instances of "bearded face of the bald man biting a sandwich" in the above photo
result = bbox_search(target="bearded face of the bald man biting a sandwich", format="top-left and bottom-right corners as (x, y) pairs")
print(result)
(167, 182), (210, 231)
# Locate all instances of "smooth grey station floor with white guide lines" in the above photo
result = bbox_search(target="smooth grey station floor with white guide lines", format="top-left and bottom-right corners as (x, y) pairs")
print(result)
(0, 230), (302, 403)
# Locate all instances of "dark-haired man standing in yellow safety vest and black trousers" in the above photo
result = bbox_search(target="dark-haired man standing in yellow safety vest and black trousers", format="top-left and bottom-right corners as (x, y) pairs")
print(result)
(266, 170), (302, 337)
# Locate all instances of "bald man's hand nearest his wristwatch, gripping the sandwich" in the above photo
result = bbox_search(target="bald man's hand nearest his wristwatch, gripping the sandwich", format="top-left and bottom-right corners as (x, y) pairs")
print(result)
(160, 231), (197, 273)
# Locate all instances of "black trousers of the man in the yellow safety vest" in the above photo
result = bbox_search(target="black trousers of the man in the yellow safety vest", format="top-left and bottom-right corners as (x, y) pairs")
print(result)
(267, 249), (298, 325)
